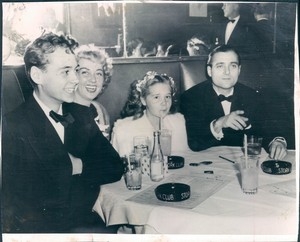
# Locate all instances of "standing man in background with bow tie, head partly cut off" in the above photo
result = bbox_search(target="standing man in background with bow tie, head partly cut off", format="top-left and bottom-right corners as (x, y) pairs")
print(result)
(214, 3), (256, 53)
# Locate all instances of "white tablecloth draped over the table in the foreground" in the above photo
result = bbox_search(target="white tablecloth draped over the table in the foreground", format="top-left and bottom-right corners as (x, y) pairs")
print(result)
(94, 147), (298, 238)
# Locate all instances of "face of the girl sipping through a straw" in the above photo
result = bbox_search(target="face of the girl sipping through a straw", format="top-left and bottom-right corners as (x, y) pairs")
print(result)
(141, 83), (172, 117)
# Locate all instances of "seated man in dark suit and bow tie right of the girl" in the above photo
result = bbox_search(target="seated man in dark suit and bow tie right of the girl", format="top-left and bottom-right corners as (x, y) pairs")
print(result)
(181, 45), (286, 159)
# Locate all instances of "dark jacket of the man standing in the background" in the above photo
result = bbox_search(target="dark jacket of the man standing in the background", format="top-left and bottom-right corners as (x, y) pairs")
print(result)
(214, 16), (257, 53)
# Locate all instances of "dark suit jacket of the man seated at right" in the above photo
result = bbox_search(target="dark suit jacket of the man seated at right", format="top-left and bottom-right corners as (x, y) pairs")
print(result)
(181, 81), (269, 151)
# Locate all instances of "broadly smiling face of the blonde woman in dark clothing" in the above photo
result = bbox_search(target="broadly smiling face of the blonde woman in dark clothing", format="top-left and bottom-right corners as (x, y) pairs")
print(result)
(76, 58), (104, 106)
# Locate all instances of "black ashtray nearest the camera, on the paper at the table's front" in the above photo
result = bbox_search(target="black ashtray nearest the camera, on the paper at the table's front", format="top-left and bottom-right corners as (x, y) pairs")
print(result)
(155, 183), (191, 202)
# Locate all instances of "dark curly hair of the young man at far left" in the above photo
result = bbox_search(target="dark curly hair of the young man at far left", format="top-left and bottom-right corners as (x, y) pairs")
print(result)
(24, 33), (78, 85)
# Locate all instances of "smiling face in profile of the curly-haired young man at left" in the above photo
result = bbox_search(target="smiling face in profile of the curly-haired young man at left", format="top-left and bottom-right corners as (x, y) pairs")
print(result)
(31, 47), (78, 110)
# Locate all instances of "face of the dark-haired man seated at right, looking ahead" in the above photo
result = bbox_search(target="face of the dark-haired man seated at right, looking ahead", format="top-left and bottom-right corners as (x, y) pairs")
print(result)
(207, 51), (241, 95)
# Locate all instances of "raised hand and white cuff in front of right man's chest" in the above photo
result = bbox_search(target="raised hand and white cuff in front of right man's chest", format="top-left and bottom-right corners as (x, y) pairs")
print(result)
(213, 110), (248, 133)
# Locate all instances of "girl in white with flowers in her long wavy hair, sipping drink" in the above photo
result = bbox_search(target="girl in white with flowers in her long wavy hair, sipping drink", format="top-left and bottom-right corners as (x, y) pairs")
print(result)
(111, 71), (189, 156)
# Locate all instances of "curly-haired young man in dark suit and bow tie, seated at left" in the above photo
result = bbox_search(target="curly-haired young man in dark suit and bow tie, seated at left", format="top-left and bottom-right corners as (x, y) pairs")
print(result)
(2, 33), (123, 233)
